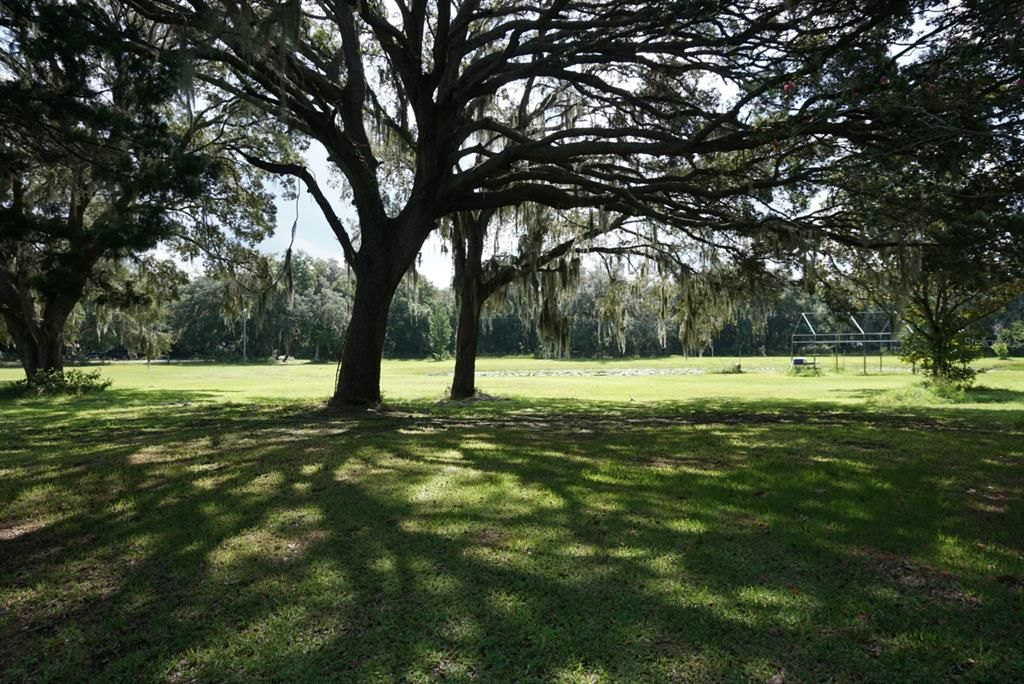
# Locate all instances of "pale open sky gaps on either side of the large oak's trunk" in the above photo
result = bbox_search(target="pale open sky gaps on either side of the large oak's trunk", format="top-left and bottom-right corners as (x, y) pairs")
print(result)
(259, 142), (452, 288)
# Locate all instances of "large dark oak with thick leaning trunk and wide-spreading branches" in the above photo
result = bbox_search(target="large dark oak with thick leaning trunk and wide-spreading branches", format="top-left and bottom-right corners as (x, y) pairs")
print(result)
(128, 0), (954, 402)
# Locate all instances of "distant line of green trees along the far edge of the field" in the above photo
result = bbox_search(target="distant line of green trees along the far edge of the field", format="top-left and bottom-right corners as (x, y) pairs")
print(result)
(0, 253), (1024, 368)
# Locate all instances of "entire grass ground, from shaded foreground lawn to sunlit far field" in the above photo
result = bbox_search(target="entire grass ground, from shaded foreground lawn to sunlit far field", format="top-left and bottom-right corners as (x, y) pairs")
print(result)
(0, 357), (1024, 682)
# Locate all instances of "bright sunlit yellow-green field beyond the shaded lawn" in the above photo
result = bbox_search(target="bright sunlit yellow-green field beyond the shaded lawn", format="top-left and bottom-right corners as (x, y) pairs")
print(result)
(6, 356), (1024, 411)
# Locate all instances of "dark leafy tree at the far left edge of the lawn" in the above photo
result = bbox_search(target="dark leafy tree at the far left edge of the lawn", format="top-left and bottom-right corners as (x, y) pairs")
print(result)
(0, 0), (271, 377)
